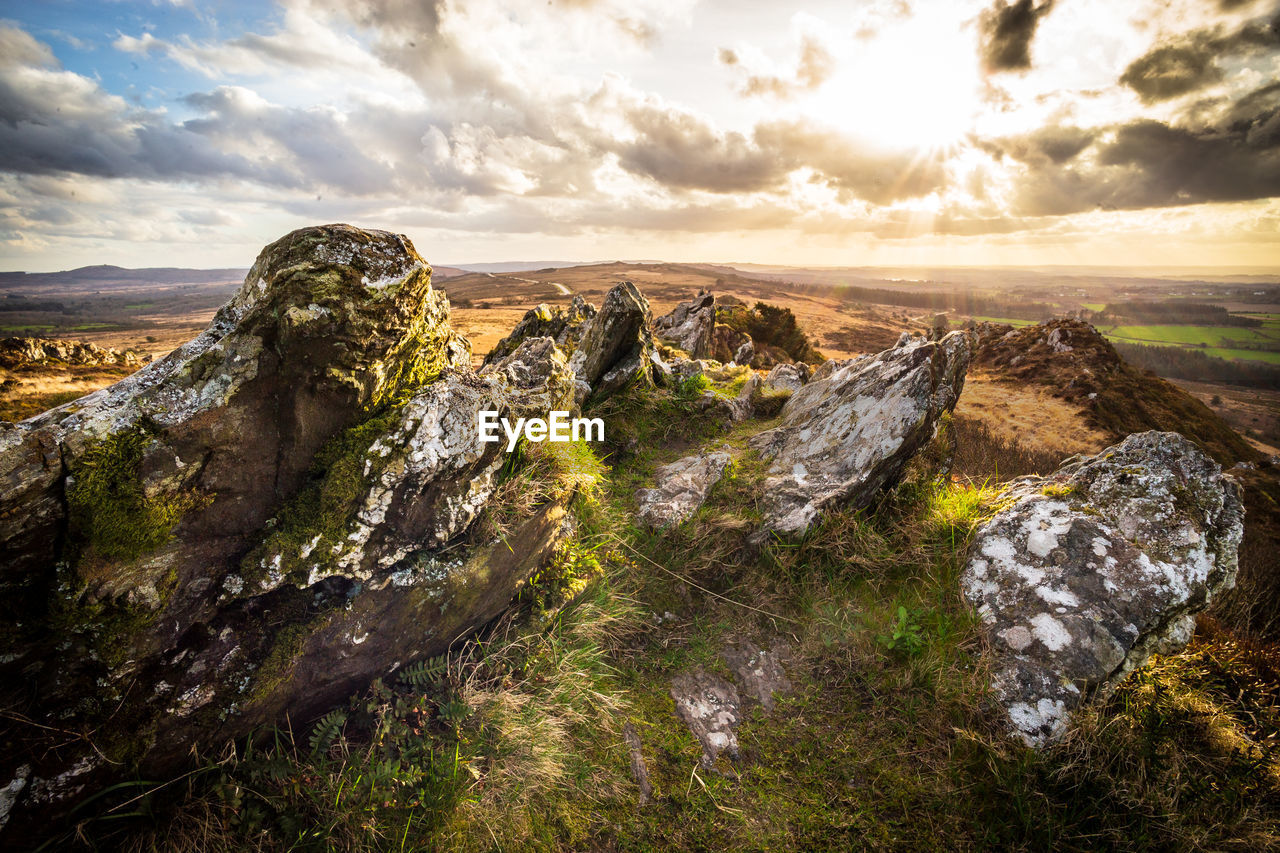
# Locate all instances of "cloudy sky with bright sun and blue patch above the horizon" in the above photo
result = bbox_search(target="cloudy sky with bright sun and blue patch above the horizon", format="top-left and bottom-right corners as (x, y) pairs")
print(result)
(0, 0), (1280, 272)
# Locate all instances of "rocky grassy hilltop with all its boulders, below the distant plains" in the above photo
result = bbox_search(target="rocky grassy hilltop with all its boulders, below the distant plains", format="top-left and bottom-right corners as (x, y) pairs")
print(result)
(0, 234), (1280, 850)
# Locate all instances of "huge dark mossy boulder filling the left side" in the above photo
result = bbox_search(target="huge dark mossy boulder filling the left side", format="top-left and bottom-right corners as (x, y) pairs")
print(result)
(0, 225), (573, 834)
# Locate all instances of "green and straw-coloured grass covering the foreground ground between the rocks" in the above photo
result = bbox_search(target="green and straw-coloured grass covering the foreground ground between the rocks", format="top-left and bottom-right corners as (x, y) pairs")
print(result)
(49, 376), (1280, 850)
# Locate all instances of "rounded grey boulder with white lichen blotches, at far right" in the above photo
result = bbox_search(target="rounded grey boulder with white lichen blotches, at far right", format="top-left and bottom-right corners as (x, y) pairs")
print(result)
(961, 432), (1244, 745)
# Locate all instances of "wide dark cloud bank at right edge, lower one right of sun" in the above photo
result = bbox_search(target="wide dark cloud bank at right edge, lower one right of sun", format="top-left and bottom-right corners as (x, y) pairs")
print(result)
(997, 85), (1280, 215)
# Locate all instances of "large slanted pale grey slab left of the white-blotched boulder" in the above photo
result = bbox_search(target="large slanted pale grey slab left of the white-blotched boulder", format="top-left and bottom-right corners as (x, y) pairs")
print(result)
(750, 332), (969, 533)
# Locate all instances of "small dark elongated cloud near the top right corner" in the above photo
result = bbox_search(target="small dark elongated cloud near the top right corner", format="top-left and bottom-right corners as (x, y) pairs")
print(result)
(1120, 12), (1280, 104)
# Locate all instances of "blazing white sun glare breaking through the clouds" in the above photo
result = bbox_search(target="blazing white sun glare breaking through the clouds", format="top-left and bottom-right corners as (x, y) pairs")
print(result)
(799, 14), (983, 150)
